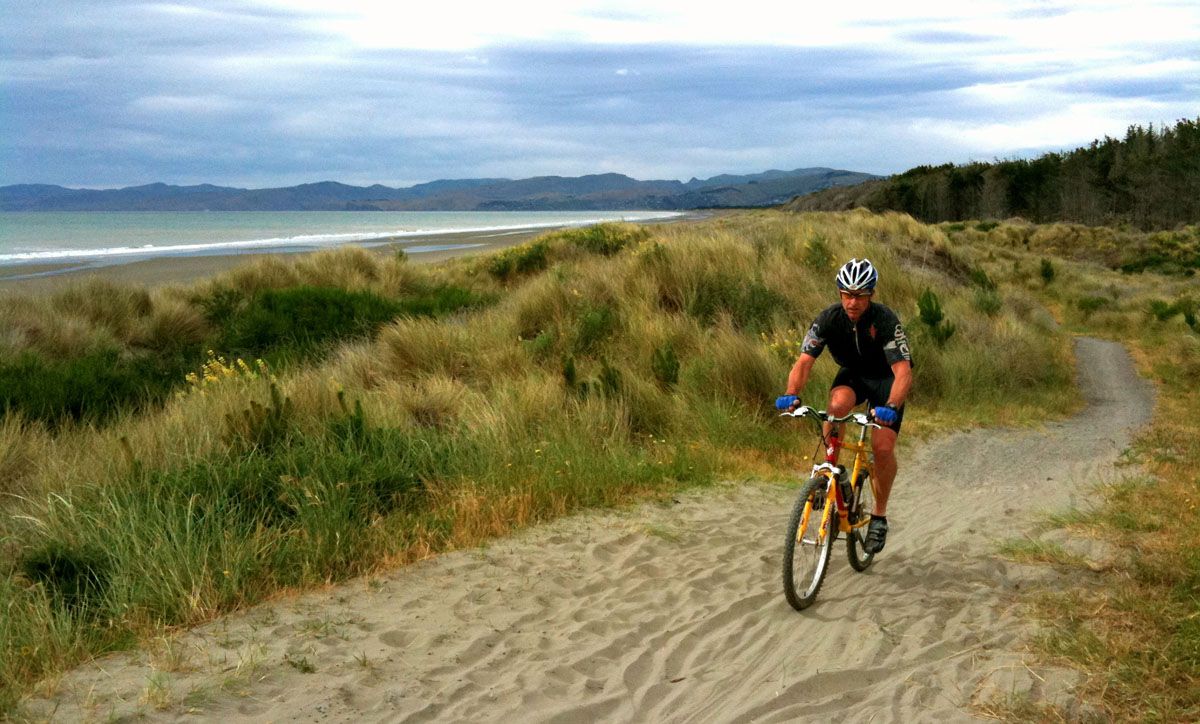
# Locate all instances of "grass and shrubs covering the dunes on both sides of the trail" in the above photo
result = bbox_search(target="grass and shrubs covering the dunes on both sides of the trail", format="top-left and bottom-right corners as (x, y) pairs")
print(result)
(0, 210), (1200, 720)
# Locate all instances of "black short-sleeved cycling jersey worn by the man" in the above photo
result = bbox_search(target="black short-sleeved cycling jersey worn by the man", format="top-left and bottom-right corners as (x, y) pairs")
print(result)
(800, 301), (912, 378)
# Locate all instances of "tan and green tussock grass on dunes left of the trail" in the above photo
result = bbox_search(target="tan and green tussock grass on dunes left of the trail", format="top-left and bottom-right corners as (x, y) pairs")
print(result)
(0, 211), (1073, 707)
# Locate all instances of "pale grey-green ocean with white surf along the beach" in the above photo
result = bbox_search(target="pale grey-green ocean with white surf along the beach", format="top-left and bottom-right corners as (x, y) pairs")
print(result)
(0, 211), (679, 267)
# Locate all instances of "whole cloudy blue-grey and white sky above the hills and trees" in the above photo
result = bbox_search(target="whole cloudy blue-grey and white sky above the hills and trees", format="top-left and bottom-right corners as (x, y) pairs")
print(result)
(0, 0), (1200, 187)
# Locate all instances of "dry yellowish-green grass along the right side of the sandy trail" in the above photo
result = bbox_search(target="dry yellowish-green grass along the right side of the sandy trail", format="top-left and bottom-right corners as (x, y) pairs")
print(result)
(960, 234), (1200, 724)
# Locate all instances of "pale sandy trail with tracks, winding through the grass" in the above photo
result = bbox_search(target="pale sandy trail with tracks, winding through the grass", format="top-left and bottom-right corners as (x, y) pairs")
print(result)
(31, 339), (1153, 724)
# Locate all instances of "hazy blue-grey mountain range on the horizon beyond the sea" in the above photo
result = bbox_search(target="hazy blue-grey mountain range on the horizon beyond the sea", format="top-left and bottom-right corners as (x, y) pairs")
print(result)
(0, 168), (880, 211)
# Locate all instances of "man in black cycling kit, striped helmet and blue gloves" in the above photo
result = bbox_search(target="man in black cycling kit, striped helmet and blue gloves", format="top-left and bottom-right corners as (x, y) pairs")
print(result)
(775, 259), (912, 554)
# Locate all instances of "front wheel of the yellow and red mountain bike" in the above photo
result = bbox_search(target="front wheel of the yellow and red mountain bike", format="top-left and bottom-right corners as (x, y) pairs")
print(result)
(784, 477), (838, 611)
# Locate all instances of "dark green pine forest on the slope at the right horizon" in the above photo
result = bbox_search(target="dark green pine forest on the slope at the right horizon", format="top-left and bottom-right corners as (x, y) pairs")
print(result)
(787, 118), (1200, 231)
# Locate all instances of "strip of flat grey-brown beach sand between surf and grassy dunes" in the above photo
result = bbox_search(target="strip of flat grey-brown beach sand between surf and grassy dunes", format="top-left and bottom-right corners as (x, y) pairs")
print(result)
(0, 211), (714, 297)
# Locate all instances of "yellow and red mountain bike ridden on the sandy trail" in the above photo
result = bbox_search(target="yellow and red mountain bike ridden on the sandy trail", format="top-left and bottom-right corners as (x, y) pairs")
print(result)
(782, 406), (880, 611)
